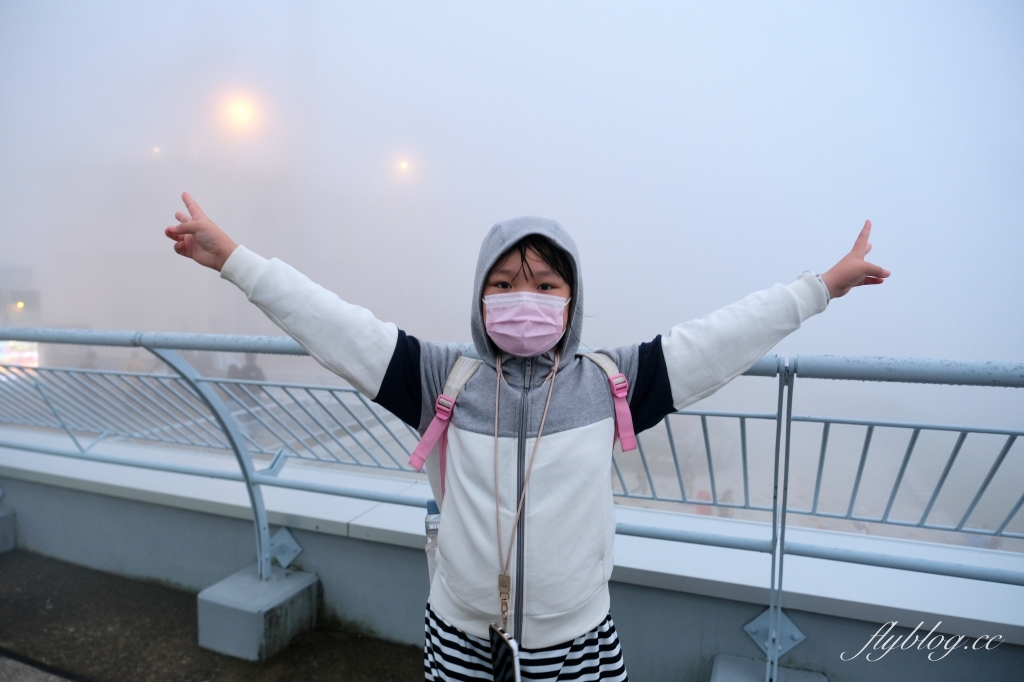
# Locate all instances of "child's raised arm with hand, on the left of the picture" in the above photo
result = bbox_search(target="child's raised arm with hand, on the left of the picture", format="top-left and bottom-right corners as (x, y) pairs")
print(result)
(165, 188), (395, 395)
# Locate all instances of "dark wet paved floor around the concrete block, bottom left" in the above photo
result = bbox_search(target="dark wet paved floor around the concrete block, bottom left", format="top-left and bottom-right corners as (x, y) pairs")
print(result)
(0, 550), (423, 682)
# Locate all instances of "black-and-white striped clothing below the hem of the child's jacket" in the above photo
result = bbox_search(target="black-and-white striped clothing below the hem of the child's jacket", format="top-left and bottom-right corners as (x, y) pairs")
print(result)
(423, 602), (629, 682)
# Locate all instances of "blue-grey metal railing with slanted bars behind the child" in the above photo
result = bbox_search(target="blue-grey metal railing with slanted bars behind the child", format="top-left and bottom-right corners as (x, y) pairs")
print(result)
(0, 328), (1024, 677)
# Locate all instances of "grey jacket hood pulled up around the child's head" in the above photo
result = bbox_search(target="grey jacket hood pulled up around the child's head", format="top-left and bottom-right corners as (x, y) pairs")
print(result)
(470, 217), (583, 367)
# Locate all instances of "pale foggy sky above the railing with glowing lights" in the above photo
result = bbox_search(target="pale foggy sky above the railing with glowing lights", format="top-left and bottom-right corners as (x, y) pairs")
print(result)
(0, 0), (1024, 372)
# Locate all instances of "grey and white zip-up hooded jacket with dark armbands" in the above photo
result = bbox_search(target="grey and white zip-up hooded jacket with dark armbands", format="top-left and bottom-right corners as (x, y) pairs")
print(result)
(221, 218), (828, 648)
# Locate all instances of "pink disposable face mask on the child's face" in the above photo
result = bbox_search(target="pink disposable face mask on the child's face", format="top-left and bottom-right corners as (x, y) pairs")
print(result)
(483, 292), (569, 357)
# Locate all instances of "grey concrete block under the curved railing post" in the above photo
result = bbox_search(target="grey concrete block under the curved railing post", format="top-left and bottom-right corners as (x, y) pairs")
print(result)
(199, 564), (319, 660)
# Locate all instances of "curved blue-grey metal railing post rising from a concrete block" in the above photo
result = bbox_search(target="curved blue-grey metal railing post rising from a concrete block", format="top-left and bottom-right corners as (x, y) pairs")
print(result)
(146, 347), (271, 581)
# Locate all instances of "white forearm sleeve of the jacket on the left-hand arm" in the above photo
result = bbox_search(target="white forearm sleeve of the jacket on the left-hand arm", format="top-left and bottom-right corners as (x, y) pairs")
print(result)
(220, 246), (398, 398)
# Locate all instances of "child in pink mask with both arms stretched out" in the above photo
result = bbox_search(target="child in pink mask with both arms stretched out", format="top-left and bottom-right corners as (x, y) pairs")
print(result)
(166, 193), (889, 680)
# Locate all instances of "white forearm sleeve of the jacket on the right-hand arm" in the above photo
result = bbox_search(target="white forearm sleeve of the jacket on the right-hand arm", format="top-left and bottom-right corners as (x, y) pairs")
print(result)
(662, 272), (828, 410)
